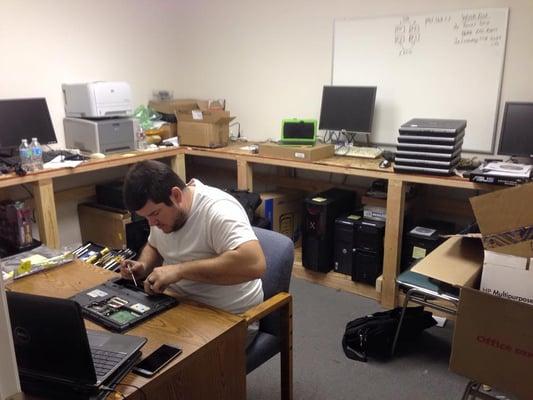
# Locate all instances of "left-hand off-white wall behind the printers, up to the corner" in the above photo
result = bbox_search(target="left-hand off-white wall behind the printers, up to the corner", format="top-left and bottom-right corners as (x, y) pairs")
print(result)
(0, 0), (185, 147)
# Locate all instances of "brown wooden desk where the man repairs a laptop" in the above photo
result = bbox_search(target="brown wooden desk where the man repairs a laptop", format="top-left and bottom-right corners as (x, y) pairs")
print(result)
(8, 261), (246, 400)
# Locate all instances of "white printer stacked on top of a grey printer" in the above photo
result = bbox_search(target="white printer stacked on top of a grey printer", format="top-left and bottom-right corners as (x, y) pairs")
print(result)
(61, 81), (133, 118)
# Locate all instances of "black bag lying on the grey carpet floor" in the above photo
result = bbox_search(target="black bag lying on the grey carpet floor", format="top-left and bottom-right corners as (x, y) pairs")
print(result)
(342, 307), (437, 362)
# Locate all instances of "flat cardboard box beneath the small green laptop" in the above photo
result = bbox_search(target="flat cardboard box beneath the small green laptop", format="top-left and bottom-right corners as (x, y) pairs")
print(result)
(259, 143), (335, 161)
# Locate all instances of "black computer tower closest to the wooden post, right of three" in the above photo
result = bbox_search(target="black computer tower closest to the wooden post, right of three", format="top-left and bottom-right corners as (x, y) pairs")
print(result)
(352, 219), (385, 285)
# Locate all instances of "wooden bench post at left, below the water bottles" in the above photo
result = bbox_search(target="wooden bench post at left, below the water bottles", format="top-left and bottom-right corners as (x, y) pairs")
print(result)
(33, 179), (59, 249)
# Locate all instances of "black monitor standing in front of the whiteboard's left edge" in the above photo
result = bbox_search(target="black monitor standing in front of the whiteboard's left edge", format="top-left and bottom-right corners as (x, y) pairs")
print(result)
(318, 86), (376, 133)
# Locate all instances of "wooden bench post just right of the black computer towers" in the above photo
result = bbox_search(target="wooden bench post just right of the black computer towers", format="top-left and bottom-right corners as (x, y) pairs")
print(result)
(381, 179), (405, 308)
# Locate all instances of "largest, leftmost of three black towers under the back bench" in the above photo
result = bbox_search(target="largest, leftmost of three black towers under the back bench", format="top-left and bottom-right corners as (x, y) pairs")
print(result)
(302, 189), (355, 272)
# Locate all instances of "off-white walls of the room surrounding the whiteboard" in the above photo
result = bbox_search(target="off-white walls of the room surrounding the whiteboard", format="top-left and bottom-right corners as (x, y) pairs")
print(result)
(0, 0), (533, 244)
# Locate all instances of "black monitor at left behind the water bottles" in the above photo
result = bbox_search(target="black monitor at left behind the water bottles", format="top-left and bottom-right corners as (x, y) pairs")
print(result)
(0, 98), (57, 149)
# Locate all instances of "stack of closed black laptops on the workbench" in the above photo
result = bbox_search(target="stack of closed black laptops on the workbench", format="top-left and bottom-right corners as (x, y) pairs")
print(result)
(394, 118), (466, 175)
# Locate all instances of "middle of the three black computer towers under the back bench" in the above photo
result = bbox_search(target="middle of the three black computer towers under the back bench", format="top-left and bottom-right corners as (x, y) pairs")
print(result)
(333, 215), (361, 275)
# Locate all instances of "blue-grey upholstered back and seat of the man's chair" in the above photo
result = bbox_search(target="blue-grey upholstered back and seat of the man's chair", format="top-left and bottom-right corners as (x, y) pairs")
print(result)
(253, 227), (294, 335)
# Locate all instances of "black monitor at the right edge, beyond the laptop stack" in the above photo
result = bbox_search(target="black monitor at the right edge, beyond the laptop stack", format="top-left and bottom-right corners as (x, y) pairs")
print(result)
(498, 102), (533, 157)
